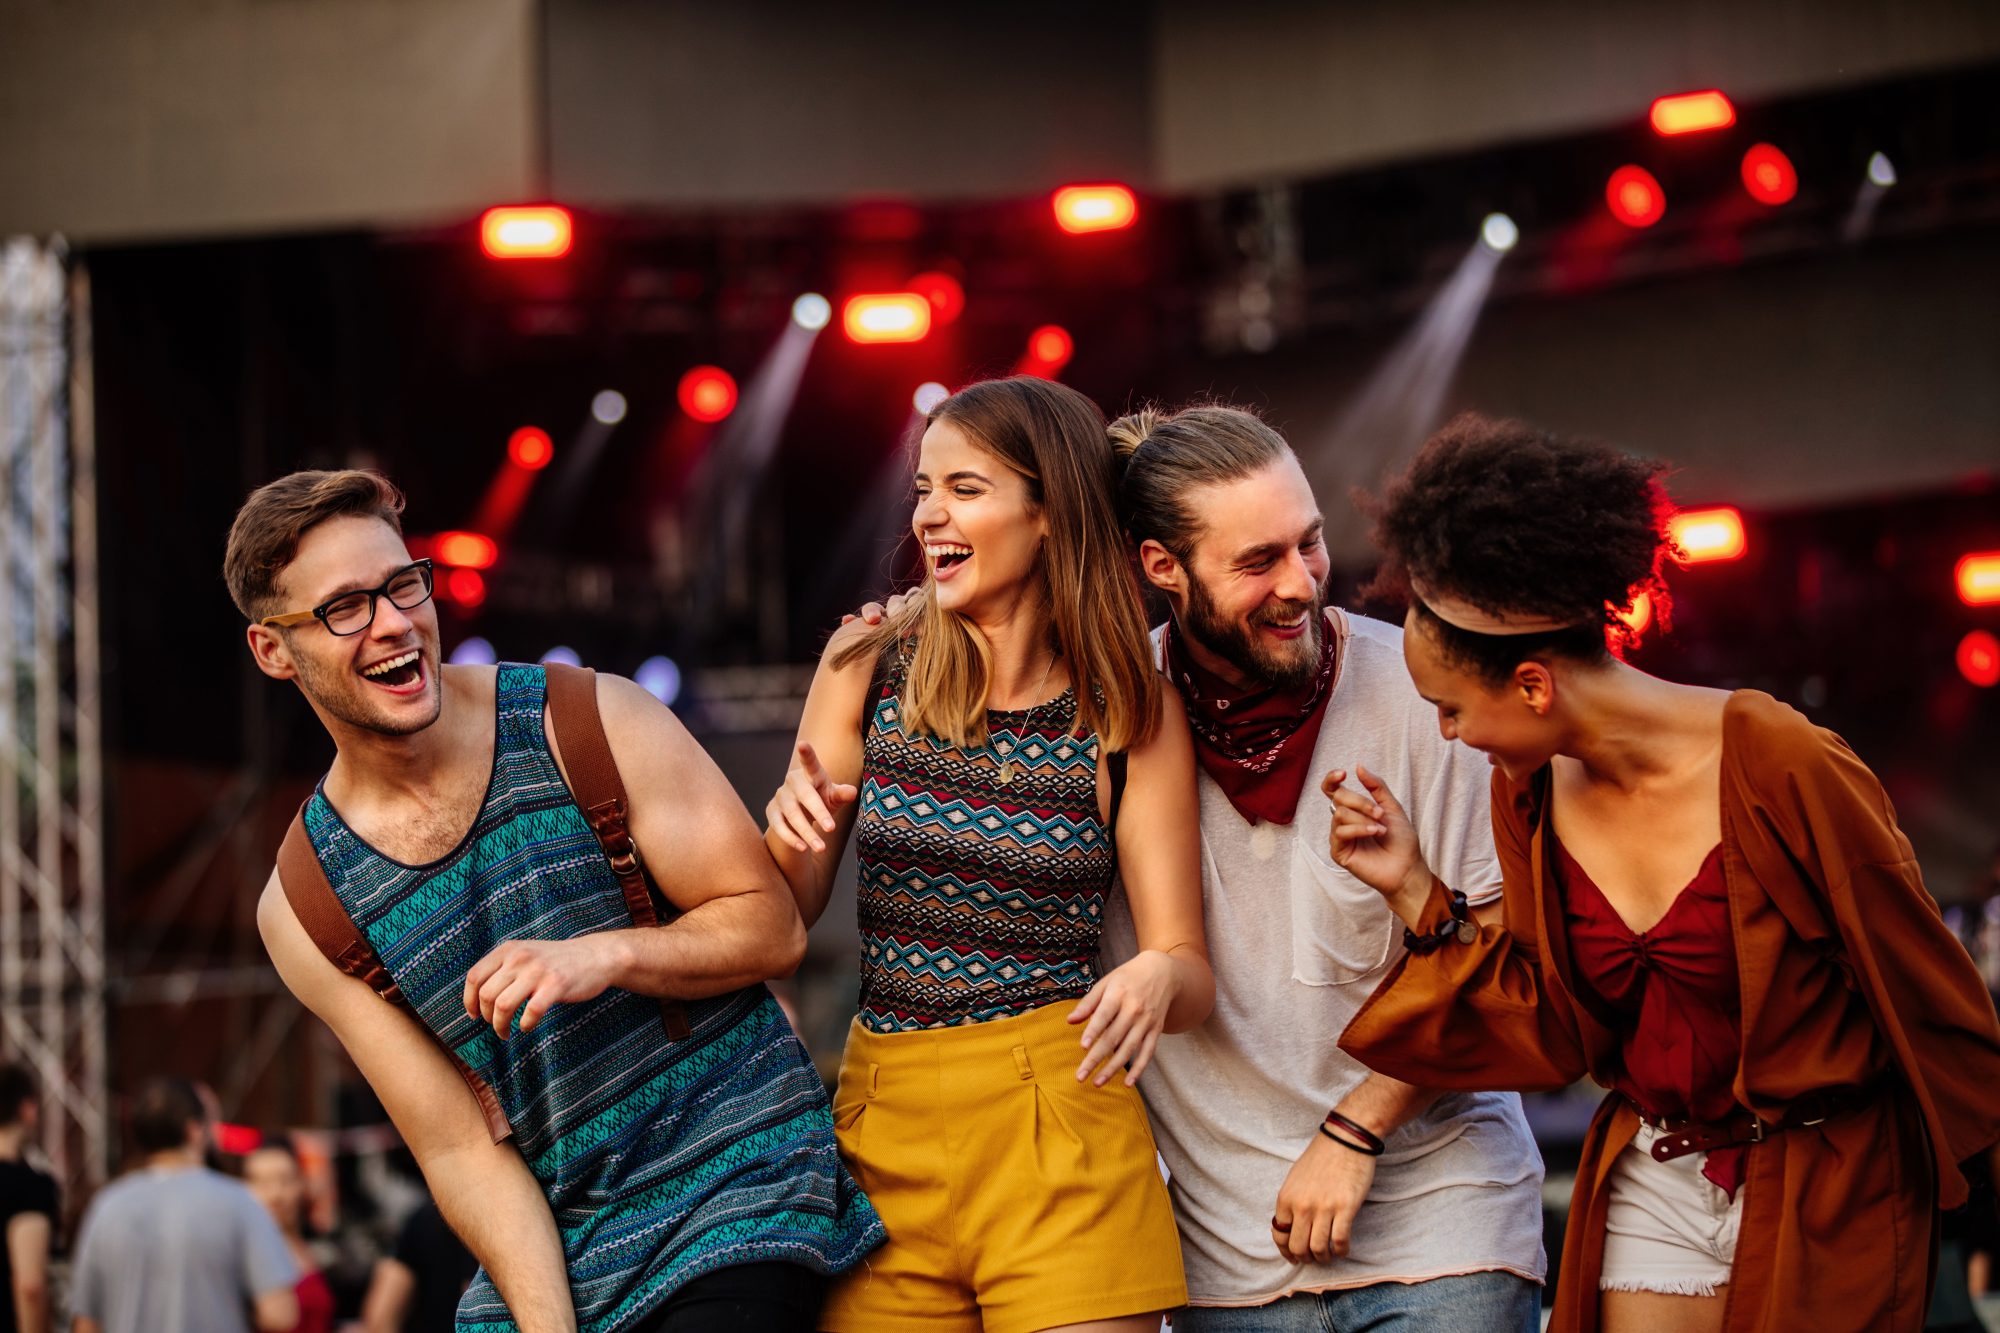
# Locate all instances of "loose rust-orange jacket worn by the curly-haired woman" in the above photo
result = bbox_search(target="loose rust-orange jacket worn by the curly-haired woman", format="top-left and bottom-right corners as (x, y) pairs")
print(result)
(1340, 691), (2000, 1333)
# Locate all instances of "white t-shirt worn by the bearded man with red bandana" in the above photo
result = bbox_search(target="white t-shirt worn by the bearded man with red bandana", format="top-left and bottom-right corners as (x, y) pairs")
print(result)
(1104, 610), (1546, 1305)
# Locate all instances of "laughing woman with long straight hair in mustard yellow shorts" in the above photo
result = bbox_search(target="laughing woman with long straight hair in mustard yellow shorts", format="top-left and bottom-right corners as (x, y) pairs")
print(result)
(764, 378), (1214, 1333)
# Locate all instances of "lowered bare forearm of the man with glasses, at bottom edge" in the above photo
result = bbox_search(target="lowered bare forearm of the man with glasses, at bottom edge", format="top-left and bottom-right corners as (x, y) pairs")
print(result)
(420, 1143), (576, 1333)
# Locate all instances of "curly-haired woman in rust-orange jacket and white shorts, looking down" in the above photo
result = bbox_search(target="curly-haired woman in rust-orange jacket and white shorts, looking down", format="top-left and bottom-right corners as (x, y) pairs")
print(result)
(1324, 414), (2000, 1333)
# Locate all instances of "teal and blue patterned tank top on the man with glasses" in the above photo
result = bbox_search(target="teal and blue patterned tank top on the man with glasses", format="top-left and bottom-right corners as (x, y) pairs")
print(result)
(306, 664), (882, 1333)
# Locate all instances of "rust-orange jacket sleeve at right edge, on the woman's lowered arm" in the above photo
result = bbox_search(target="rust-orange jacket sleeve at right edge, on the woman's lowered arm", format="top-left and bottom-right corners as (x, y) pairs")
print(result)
(1760, 715), (2000, 1207)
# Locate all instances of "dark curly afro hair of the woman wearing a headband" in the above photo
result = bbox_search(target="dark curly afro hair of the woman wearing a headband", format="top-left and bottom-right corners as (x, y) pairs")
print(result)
(1360, 412), (1678, 681)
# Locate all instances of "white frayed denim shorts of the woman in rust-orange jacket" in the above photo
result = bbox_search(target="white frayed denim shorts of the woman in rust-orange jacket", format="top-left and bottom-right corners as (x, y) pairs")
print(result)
(1598, 1123), (1744, 1295)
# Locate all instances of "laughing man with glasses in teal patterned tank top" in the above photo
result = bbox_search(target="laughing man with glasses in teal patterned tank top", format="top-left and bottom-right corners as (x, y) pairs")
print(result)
(224, 470), (882, 1333)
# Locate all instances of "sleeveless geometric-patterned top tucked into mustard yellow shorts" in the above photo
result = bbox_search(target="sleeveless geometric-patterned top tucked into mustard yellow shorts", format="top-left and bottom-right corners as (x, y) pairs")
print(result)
(854, 662), (1118, 1033)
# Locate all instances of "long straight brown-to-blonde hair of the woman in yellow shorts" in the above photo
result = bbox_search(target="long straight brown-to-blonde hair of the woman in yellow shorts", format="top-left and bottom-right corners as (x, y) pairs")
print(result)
(834, 376), (1160, 753)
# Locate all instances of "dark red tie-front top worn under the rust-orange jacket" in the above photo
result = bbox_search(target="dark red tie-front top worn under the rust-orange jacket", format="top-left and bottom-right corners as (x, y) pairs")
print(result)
(1556, 845), (1746, 1197)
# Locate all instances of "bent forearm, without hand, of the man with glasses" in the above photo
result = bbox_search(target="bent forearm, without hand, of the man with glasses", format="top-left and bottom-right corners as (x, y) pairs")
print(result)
(608, 891), (806, 999)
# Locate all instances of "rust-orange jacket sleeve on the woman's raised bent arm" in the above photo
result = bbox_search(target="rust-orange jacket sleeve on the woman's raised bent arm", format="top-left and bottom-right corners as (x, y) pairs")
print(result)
(1340, 775), (1588, 1093)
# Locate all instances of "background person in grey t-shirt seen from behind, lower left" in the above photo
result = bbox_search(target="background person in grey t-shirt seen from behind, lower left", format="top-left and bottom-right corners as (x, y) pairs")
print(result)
(70, 1079), (298, 1333)
